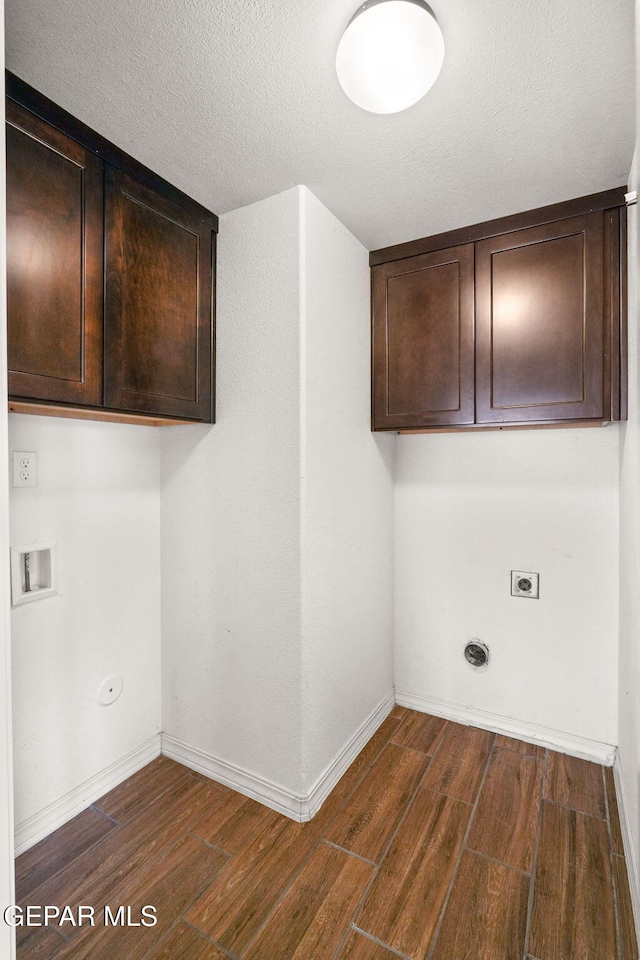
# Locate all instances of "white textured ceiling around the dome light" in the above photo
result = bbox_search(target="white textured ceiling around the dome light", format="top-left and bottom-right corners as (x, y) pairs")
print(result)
(6, 0), (635, 249)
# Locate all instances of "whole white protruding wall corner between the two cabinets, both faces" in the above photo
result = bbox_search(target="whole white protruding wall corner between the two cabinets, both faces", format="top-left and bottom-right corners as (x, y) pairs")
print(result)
(162, 188), (393, 815)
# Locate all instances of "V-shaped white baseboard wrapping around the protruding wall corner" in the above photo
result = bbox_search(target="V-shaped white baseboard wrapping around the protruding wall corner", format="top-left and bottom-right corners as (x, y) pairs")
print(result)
(162, 691), (395, 823)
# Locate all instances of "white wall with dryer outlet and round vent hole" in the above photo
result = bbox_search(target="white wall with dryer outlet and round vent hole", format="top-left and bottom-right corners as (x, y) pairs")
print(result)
(395, 426), (620, 744)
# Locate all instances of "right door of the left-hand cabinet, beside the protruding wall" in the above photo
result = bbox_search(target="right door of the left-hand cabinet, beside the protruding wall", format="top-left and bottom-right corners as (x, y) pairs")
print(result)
(105, 166), (213, 421)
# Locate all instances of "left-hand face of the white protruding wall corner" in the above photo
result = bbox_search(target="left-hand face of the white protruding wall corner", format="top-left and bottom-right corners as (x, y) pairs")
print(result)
(162, 188), (301, 792)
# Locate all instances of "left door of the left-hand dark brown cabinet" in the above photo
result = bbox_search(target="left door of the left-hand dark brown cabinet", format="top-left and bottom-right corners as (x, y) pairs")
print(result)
(7, 100), (103, 405)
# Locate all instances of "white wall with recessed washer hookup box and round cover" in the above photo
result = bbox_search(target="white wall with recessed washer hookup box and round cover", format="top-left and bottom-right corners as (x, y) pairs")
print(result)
(9, 415), (160, 824)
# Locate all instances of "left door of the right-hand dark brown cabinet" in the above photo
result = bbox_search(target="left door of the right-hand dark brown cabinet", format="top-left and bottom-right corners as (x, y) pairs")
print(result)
(373, 244), (474, 430)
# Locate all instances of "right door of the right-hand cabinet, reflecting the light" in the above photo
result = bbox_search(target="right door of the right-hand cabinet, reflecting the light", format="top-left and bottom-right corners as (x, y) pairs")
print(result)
(476, 211), (605, 423)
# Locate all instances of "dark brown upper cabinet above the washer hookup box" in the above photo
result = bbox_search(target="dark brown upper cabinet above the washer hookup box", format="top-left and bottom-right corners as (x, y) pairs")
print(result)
(7, 74), (218, 423)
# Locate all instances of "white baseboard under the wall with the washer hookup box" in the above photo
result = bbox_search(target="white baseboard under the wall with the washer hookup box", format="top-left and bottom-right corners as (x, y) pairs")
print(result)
(15, 733), (160, 856)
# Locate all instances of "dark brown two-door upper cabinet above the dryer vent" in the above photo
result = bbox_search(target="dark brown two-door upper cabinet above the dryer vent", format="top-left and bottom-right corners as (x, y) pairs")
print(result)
(370, 188), (626, 431)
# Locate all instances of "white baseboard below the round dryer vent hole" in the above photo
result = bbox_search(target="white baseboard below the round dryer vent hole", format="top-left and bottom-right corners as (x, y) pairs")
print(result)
(396, 689), (616, 767)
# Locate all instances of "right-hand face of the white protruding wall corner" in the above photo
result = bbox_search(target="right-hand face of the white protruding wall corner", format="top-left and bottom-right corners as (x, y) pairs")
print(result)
(302, 189), (396, 790)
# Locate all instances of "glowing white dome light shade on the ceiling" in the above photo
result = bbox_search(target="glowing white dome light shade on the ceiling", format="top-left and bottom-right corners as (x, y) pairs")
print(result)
(336, 0), (444, 113)
